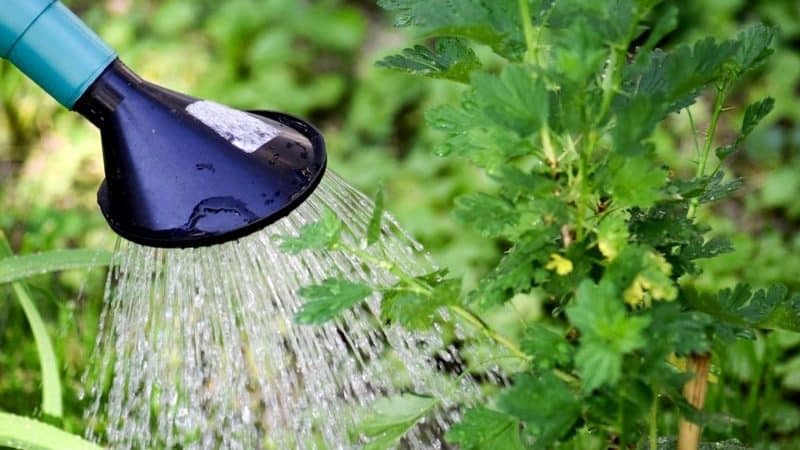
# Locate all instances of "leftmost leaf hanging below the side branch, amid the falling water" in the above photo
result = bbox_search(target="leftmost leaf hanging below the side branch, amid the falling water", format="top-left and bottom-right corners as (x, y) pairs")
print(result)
(295, 278), (372, 324)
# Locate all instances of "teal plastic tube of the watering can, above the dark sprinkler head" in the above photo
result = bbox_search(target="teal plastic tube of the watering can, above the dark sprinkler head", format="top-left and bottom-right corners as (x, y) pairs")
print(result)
(0, 0), (117, 109)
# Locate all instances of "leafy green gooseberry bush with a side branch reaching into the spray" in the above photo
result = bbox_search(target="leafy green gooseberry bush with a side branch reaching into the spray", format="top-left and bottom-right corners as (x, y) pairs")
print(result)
(283, 0), (800, 450)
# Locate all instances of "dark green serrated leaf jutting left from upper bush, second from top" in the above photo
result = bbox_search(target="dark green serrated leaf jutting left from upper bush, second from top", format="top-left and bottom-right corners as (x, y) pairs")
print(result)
(378, 38), (481, 83)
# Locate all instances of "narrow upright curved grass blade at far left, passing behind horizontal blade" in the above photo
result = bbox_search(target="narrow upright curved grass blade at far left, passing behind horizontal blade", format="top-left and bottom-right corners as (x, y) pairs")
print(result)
(0, 236), (64, 418)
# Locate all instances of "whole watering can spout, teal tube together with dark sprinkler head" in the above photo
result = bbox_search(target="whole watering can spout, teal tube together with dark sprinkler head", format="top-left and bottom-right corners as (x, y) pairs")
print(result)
(0, 0), (326, 247)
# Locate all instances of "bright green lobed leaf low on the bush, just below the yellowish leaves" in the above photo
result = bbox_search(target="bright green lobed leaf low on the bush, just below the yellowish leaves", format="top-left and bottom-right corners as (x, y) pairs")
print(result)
(566, 280), (650, 392)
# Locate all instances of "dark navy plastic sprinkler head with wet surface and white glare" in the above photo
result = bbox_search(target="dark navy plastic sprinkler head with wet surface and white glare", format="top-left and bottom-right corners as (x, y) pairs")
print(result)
(74, 61), (326, 248)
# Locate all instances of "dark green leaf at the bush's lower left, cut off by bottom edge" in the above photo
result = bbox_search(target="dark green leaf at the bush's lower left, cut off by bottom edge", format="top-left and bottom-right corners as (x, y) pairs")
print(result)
(445, 406), (525, 450)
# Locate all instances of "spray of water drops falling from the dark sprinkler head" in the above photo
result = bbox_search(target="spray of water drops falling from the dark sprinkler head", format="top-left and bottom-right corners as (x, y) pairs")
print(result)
(85, 172), (477, 450)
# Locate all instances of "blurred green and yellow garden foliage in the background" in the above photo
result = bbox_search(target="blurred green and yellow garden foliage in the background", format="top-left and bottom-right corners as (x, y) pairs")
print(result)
(0, 0), (800, 448)
